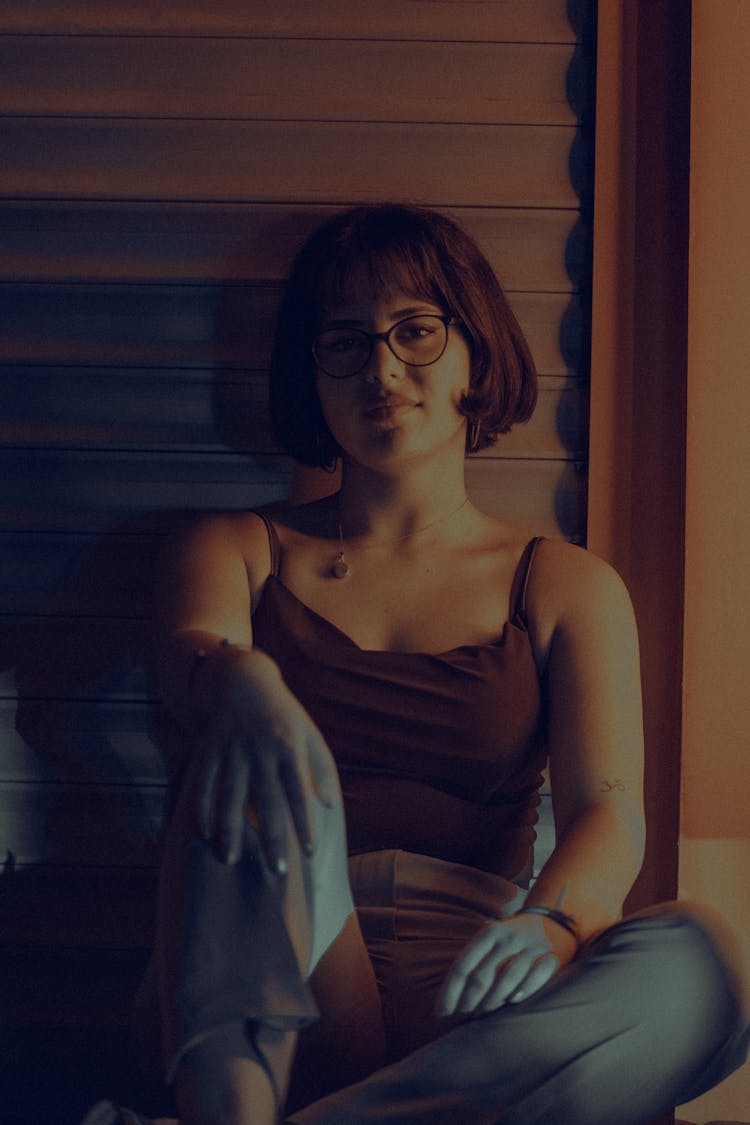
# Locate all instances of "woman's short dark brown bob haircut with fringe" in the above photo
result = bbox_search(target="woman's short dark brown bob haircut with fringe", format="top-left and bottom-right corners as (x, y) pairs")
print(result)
(270, 204), (536, 468)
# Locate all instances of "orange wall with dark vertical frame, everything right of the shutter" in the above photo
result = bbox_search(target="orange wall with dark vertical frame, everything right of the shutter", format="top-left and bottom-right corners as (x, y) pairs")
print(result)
(588, 0), (750, 1125)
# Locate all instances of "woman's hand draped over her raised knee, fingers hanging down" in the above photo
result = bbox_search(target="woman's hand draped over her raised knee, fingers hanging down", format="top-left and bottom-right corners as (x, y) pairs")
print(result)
(197, 649), (340, 874)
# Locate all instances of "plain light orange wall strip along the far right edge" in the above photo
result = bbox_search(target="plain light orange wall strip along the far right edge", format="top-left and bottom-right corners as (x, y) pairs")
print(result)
(679, 0), (750, 1123)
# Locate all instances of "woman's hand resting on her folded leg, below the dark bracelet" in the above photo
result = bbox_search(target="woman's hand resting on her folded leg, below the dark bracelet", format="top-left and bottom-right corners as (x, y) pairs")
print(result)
(437, 914), (577, 1016)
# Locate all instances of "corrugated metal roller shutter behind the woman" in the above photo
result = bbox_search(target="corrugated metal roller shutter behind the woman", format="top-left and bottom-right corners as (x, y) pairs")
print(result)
(0, 0), (588, 1030)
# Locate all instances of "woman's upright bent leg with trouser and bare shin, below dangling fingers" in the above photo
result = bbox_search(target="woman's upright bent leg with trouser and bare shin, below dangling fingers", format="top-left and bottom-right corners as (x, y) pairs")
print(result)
(150, 756), (353, 1125)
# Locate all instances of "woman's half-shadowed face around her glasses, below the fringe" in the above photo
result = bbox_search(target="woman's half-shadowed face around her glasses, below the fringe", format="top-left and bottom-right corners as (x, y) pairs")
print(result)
(316, 290), (470, 469)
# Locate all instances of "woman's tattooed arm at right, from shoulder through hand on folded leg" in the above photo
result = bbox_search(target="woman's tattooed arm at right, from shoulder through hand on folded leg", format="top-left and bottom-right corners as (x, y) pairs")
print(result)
(437, 542), (644, 1016)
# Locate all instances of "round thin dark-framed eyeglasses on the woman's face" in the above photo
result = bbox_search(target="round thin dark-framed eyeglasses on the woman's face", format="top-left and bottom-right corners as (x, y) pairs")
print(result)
(313, 313), (461, 379)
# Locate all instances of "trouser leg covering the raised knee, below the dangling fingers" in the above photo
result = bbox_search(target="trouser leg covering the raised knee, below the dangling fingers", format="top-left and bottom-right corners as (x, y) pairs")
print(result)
(154, 762), (353, 1081)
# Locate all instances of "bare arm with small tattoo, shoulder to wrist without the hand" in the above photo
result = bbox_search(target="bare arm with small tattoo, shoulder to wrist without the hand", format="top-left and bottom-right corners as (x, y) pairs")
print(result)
(519, 543), (645, 941)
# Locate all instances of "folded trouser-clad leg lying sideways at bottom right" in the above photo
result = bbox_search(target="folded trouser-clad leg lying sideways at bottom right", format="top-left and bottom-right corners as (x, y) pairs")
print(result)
(288, 909), (748, 1125)
